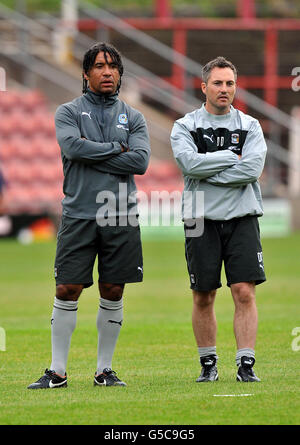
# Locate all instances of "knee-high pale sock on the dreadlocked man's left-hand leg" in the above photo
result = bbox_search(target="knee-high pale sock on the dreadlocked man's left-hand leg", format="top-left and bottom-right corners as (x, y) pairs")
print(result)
(50, 297), (78, 376)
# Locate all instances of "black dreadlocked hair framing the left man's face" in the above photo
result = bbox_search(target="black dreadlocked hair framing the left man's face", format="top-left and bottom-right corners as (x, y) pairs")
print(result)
(82, 42), (124, 93)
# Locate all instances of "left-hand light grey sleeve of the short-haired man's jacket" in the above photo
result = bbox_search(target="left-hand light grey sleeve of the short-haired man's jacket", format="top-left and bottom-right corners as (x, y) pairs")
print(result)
(171, 121), (238, 179)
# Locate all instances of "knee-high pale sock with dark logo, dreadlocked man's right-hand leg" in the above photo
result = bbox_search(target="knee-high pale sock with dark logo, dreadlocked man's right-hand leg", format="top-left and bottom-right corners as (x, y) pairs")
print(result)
(97, 298), (123, 374)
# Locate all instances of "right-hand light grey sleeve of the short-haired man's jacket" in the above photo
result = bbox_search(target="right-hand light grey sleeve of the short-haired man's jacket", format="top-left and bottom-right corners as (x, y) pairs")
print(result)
(206, 120), (267, 187)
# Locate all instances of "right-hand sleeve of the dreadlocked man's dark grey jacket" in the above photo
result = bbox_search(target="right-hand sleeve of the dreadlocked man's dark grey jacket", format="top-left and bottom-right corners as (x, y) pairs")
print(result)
(92, 113), (150, 175)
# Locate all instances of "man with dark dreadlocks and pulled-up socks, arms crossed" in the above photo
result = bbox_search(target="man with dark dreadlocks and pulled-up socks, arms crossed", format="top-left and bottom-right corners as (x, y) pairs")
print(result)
(28, 43), (150, 389)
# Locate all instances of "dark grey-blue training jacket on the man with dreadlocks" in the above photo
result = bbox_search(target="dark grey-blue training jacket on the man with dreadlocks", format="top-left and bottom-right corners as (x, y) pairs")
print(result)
(55, 90), (150, 219)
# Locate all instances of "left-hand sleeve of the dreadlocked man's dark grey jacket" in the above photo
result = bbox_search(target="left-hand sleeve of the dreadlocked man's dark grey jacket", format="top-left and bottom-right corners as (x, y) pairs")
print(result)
(55, 105), (122, 164)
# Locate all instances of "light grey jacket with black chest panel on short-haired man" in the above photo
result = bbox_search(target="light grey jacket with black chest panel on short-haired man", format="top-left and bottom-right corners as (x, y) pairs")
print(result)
(171, 105), (267, 220)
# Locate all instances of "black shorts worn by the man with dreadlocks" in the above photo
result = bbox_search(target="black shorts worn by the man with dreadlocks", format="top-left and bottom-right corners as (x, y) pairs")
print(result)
(55, 215), (143, 287)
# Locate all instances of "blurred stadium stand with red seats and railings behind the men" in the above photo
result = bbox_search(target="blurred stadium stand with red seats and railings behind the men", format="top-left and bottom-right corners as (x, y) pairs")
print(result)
(0, 0), (300, 239)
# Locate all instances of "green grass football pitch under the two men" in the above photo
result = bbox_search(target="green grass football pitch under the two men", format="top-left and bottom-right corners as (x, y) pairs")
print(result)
(0, 233), (300, 425)
